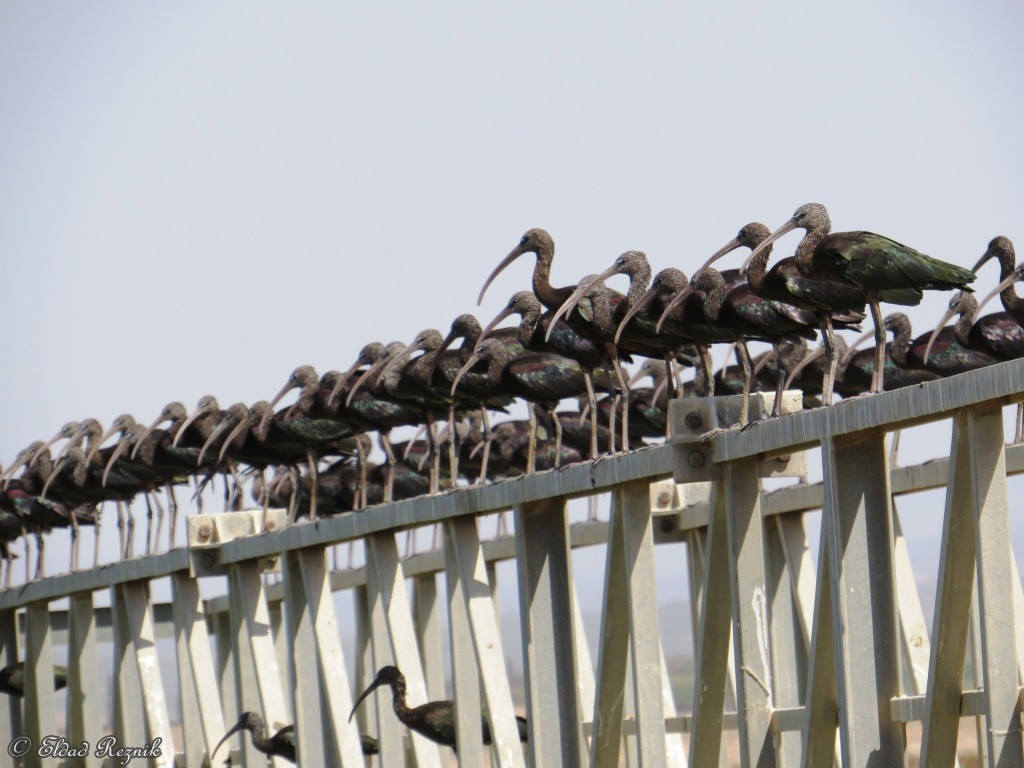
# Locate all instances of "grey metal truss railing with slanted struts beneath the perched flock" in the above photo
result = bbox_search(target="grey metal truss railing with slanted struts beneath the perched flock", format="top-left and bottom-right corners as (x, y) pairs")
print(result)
(0, 361), (1024, 768)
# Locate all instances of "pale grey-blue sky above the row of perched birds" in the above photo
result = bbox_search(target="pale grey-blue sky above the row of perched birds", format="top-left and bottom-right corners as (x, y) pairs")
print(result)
(0, 2), (1024, 577)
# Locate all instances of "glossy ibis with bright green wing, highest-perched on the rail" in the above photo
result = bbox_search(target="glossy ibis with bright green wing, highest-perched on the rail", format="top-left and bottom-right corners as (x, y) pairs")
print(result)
(752, 203), (975, 392)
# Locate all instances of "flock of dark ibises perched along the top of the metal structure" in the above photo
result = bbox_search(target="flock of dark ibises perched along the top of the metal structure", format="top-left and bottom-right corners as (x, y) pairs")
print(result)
(0, 203), (1024, 586)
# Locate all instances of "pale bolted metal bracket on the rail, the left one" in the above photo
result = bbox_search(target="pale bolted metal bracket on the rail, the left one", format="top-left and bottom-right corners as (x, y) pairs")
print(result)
(185, 509), (288, 579)
